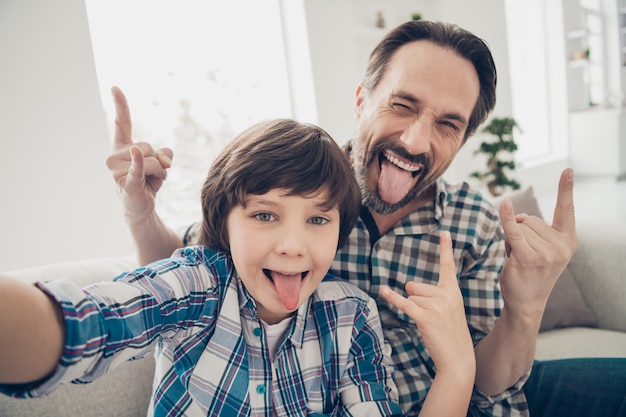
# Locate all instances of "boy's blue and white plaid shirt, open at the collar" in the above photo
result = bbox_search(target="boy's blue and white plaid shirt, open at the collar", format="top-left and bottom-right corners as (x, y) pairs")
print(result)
(3, 247), (402, 416)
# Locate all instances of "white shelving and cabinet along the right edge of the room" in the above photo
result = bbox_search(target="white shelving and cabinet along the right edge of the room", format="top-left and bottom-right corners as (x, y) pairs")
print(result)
(563, 0), (626, 178)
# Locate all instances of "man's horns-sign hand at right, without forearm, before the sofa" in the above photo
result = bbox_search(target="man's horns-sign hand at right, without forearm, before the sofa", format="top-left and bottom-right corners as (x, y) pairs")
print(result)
(500, 169), (578, 320)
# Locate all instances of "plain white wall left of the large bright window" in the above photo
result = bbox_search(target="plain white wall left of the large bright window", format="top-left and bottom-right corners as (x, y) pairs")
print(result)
(0, 0), (132, 271)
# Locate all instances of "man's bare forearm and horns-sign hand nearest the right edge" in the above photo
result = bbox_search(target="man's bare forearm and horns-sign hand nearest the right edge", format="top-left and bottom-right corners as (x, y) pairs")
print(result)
(475, 169), (578, 395)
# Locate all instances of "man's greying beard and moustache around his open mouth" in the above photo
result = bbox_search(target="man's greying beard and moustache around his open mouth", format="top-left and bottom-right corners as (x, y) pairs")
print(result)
(352, 142), (435, 214)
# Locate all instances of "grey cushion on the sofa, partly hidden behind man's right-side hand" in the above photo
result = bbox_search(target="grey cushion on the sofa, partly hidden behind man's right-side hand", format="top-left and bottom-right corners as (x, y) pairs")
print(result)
(495, 186), (598, 331)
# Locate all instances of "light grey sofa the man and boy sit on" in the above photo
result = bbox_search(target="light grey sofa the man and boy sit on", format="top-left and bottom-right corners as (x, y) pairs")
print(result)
(0, 188), (626, 417)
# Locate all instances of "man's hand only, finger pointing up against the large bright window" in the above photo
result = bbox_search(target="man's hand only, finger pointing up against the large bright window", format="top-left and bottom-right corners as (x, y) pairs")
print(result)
(106, 87), (174, 226)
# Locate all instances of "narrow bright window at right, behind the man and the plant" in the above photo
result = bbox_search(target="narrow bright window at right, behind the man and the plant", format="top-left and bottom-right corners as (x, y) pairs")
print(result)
(505, 0), (568, 166)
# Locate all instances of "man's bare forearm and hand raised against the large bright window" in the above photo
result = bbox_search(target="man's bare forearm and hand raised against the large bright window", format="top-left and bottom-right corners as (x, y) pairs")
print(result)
(106, 87), (183, 265)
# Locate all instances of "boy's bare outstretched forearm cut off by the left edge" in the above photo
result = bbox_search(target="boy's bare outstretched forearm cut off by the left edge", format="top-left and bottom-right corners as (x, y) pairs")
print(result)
(0, 277), (65, 384)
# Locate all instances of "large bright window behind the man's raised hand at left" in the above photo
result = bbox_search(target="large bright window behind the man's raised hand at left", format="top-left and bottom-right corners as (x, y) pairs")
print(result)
(86, 0), (292, 228)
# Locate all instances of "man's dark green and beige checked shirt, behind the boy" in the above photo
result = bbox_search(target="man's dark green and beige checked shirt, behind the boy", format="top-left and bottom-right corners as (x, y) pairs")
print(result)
(331, 179), (528, 416)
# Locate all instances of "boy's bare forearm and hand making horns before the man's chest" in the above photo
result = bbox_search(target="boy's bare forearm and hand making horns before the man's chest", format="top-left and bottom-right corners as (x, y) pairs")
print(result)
(381, 232), (476, 417)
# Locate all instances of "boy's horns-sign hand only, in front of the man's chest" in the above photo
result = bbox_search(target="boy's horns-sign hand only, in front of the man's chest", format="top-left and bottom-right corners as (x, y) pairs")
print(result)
(381, 231), (475, 374)
